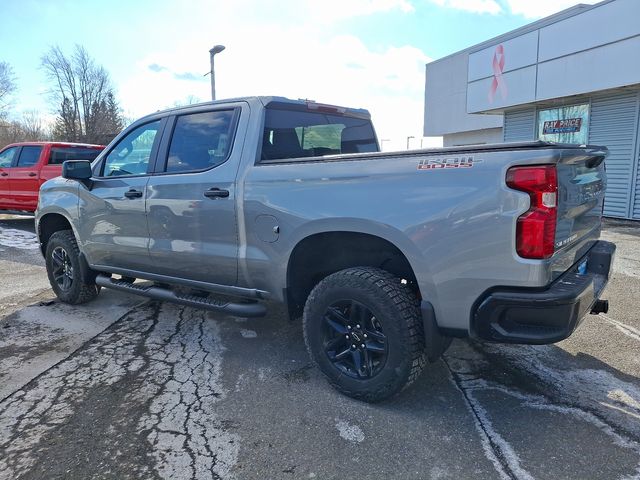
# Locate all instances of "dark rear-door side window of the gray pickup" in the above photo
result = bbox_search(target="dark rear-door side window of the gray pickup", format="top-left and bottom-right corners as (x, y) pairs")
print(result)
(165, 110), (235, 172)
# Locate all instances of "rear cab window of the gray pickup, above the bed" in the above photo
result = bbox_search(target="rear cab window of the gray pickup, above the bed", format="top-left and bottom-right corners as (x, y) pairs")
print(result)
(260, 104), (379, 163)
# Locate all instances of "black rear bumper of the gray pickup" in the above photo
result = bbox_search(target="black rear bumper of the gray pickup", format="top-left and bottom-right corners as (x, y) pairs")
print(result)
(471, 241), (616, 344)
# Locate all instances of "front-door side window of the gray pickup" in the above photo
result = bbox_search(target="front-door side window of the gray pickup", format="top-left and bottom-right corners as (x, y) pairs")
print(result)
(102, 120), (160, 177)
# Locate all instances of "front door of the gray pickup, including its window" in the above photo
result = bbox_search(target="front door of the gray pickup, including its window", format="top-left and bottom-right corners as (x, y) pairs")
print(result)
(78, 120), (161, 271)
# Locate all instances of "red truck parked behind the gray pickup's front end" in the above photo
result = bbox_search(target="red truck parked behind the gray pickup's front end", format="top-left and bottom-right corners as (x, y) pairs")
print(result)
(0, 142), (104, 213)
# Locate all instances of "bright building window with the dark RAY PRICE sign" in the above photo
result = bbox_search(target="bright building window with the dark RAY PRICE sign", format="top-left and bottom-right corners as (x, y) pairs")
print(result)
(538, 104), (589, 145)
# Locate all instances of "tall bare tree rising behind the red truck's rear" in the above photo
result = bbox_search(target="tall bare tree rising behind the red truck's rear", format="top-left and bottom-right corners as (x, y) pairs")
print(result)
(41, 45), (122, 143)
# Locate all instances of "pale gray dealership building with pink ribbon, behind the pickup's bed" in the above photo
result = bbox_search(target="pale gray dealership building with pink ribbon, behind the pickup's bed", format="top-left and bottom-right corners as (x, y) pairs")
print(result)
(424, 0), (640, 220)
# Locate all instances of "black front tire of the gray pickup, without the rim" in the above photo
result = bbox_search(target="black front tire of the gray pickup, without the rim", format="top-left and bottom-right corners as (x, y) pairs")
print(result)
(45, 230), (100, 305)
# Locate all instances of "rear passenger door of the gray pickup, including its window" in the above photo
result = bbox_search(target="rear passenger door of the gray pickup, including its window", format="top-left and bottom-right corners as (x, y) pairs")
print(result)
(147, 106), (242, 285)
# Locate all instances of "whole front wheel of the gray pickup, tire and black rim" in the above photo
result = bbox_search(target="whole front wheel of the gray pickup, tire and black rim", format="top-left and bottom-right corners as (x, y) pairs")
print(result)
(45, 230), (100, 305)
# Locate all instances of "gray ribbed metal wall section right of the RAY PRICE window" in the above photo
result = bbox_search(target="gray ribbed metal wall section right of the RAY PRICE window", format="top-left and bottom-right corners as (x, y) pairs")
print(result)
(589, 91), (640, 218)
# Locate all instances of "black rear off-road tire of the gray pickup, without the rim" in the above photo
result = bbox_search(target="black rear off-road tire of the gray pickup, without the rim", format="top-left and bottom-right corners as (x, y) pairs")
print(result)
(303, 267), (426, 402)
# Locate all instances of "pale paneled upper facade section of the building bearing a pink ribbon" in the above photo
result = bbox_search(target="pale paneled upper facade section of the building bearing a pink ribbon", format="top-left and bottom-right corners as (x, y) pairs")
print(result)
(462, 0), (640, 113)
